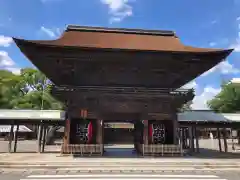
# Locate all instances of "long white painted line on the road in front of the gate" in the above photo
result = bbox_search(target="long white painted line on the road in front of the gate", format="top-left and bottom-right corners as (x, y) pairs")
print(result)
(28, 174), (218, 178)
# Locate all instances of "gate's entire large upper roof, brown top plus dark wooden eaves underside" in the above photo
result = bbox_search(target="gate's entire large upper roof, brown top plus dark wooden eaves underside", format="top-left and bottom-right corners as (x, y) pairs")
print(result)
(13, 25), (232, 89)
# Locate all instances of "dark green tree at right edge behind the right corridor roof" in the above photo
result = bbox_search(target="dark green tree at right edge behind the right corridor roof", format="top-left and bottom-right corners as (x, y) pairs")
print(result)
(208, 83), (240, 113)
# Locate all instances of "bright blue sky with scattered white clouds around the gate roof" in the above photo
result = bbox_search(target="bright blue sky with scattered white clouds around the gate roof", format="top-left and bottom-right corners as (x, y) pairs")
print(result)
(0, 0), (240, 109)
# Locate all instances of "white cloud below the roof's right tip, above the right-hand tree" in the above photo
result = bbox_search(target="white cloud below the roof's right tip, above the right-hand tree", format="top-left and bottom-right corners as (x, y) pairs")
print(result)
(202, 61), (240, 76)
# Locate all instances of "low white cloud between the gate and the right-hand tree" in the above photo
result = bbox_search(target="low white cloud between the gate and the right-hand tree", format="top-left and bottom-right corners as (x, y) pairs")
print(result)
(191, 86), (221, 110)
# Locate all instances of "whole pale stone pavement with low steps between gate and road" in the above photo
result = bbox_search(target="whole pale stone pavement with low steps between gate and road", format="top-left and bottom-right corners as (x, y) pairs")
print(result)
(0, 153), (240, 173)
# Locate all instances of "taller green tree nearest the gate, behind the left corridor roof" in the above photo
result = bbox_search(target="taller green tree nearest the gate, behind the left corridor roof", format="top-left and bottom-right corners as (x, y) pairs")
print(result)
(10, 68), (63, 110)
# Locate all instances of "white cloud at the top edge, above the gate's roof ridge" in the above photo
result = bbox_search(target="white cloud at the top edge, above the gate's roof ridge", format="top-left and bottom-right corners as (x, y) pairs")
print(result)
(101, 0), (133, 23)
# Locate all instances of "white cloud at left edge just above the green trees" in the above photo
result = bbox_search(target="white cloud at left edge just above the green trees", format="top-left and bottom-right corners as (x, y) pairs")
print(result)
(0, 51), (20, 74)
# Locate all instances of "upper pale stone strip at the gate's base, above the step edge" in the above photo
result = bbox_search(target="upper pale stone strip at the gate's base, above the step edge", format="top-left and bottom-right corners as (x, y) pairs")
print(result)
(0, 153), (240, 164)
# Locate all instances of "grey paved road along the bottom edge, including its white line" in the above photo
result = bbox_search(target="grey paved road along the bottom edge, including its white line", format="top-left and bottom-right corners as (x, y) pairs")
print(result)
(0, 171), (240, 180)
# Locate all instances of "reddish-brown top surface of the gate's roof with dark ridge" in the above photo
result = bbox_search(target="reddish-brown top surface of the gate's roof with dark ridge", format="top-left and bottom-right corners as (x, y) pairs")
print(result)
(13, 25), (232, 55)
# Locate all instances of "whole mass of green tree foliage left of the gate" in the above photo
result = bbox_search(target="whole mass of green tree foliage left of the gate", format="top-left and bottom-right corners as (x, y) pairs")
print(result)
(0, 68), (63, 109)
